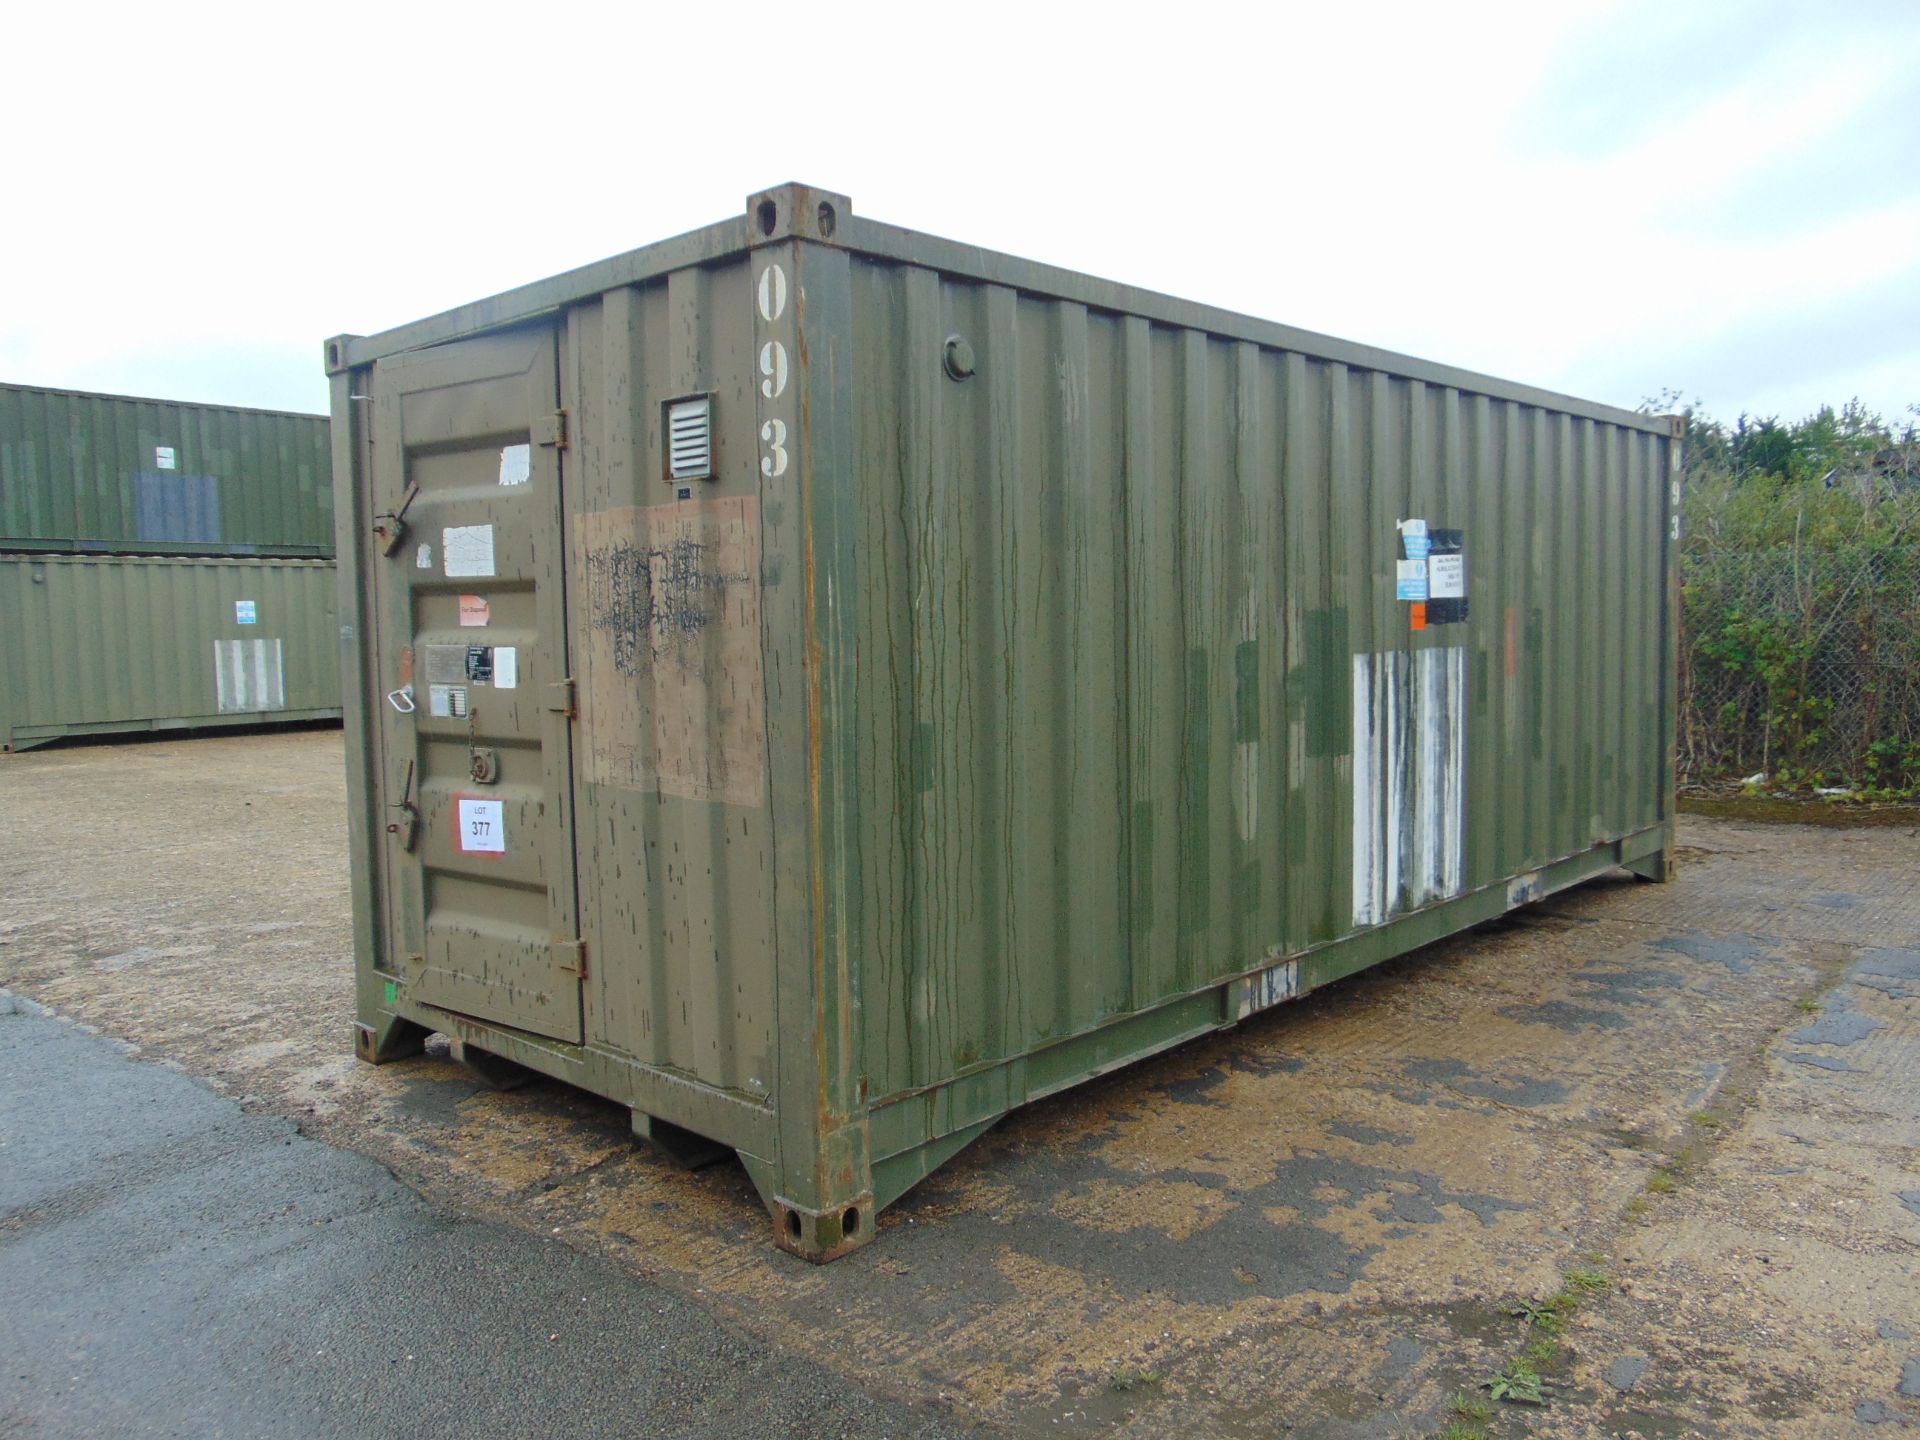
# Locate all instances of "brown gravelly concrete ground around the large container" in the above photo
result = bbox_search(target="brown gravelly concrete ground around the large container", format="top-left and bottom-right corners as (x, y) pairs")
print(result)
(0, 732), (1920, 1438)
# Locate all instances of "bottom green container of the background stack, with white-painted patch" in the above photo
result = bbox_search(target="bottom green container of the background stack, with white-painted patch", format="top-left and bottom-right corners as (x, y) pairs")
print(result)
(0, 555), (340, 751)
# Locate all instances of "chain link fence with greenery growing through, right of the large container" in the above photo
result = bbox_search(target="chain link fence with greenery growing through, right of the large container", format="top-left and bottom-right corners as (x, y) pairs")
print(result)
(1678, 526), (1920, 791)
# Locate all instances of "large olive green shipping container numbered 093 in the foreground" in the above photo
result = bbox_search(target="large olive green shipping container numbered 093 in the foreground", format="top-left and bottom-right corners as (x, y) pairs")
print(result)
(326, 186), (1678, 1260)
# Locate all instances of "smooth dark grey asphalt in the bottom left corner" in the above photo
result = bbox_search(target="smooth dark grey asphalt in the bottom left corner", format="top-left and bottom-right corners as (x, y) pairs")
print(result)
(0, 1014), (966, 1440)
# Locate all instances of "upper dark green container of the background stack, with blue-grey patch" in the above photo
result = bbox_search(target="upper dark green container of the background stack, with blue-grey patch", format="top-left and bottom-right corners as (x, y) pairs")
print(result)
(0, 386), (334, 557)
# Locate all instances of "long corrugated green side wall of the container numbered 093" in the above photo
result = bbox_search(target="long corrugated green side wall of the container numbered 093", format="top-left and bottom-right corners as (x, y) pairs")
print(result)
(839, 259), (1672, 1131)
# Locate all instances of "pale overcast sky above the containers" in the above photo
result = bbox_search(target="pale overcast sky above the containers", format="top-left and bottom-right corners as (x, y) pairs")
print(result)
(0, 0), (1920, 428)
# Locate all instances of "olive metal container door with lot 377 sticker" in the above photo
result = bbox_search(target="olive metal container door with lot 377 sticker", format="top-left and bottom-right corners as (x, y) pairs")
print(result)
(371, 328), (582, 1043)
